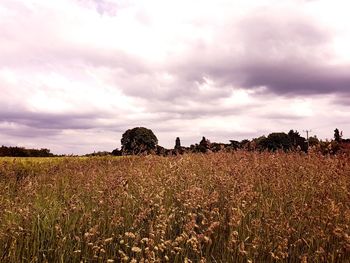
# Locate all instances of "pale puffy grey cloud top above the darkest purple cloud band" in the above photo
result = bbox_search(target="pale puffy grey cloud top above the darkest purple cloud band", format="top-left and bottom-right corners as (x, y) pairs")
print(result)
(238, 9), (331, 57)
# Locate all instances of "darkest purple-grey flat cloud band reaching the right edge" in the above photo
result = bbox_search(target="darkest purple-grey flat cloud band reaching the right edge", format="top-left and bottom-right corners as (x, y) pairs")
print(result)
(240, 63), (350, 95)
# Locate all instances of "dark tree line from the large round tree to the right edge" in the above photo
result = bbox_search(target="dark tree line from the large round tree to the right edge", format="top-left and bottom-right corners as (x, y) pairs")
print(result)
(112, 127), (350, 156)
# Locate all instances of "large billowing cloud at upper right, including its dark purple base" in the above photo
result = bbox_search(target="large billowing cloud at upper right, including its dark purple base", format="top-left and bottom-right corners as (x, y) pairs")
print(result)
(167, 10), (350, 99)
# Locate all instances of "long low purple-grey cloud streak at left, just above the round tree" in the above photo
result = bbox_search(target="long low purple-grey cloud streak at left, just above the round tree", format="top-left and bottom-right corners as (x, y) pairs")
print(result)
(0, 106), (171, 137)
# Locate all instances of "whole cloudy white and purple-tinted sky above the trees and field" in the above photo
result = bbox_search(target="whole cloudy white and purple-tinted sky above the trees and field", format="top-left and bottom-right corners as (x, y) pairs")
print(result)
(0, 0), (350, 154)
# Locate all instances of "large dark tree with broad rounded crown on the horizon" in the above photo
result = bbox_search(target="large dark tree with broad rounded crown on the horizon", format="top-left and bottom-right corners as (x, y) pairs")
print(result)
(121, 127), (158, 155)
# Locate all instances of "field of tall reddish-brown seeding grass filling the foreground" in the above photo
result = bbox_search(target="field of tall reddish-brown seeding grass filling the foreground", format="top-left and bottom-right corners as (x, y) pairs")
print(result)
(0, 151), (350, 263)
